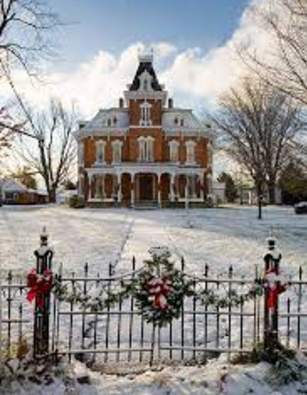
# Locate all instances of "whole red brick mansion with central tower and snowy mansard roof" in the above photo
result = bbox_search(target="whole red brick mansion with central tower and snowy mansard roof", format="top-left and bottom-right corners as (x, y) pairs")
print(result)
(75, 55), (212, 207)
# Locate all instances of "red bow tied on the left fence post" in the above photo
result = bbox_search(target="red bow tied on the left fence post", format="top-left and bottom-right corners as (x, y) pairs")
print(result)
(27, 269), (52, 308)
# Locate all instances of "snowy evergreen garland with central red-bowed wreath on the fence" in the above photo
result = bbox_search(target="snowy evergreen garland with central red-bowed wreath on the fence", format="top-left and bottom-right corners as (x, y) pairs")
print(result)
(47, 247), (265, 326)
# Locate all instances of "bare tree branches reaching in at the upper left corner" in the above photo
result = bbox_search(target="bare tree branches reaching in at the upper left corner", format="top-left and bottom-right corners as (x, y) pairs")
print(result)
(0, 0), (60, 150)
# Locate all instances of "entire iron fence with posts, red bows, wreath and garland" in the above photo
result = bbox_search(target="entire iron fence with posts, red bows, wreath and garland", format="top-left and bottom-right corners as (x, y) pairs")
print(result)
(0, 232), (307, 363)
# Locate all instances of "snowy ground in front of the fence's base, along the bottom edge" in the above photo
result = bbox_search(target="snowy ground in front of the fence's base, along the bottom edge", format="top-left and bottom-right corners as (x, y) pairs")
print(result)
(5, 358), (307, 395)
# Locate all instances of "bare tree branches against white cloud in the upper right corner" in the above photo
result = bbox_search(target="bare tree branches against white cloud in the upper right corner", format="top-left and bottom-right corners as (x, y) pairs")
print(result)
(243, 0), (307, 105)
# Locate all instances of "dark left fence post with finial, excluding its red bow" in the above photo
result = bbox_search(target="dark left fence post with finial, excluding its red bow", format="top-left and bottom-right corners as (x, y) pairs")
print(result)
(33, 227), (53, 358)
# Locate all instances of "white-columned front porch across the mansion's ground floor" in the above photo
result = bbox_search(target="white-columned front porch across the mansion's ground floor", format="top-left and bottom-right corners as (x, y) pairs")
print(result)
(79, 165), (210, 207)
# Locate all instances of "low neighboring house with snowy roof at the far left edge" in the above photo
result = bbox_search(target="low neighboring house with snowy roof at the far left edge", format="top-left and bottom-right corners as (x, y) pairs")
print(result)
(0, 179), (48, 204)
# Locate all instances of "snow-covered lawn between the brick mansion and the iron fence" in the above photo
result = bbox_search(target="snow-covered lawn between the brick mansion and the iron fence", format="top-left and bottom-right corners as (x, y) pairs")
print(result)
(0, 206), (307, 274)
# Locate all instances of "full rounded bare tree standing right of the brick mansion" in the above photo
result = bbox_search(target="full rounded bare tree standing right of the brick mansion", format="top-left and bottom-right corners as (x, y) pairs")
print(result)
(212, 78), (302, 203)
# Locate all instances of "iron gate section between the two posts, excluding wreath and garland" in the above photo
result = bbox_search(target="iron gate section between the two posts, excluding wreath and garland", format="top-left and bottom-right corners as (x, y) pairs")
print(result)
(52, 258), (262, 363)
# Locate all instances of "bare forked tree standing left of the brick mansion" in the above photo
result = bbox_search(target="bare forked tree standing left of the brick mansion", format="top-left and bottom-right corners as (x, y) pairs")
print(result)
(18, 100), (76, 202)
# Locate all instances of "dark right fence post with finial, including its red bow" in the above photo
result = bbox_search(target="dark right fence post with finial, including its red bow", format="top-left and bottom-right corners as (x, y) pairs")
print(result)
(263, 237), (281, 349)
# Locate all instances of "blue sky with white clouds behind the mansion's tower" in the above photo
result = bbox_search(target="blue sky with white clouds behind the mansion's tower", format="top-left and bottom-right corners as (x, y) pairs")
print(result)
(1, 0), (266, 118)
